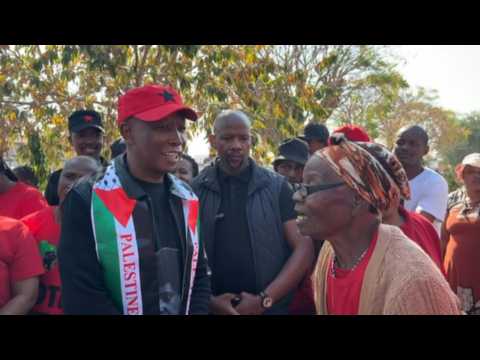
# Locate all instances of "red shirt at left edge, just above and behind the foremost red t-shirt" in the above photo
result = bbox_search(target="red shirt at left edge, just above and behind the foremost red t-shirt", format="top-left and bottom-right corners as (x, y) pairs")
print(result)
(0, 181), (48, 220)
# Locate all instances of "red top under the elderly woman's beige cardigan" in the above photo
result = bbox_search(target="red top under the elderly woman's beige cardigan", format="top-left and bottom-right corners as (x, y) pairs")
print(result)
(327, 231), (378, 315)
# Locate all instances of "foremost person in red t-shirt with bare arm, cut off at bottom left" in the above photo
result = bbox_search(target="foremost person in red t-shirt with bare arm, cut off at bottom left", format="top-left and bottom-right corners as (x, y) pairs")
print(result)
(0, 216), (43, 315)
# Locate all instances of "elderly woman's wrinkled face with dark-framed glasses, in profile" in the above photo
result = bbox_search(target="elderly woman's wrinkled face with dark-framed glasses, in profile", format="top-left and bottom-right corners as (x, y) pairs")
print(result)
(293, 155), (355, 241)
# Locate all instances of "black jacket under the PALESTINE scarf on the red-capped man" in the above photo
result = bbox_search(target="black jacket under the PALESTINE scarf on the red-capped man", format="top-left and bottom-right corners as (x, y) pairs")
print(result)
(58, 156), (211, 314)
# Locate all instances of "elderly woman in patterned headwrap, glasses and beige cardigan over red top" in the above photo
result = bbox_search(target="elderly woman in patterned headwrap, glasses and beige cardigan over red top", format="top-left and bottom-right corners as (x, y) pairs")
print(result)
(294, 136), (461, 315)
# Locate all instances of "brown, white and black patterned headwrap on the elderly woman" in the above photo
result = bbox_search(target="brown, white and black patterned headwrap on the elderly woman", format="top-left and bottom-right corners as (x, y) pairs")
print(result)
(315, 134), (410, 211)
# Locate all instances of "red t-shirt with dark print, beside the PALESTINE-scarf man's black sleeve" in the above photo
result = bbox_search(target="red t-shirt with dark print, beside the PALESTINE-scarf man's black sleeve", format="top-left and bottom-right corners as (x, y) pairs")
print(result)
(22, 206), (63, 315)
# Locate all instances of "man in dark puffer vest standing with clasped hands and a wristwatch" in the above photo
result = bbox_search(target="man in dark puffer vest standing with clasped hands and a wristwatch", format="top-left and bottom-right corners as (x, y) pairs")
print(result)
(193, 111), (313, 315)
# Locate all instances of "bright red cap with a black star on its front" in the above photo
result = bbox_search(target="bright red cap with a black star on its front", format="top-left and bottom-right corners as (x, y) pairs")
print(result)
(117, 85), (198, 125)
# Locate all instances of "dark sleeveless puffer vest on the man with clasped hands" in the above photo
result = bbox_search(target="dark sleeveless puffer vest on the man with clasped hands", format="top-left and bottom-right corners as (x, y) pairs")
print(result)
(193, 160), (292, 314)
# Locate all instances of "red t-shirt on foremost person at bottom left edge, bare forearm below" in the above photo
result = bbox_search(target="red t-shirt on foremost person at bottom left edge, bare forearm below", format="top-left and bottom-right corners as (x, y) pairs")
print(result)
(0, 216), (44, 308)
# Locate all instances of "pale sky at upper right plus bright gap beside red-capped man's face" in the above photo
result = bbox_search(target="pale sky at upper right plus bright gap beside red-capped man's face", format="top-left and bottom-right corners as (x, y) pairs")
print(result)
(189, 45), (480, 161)
